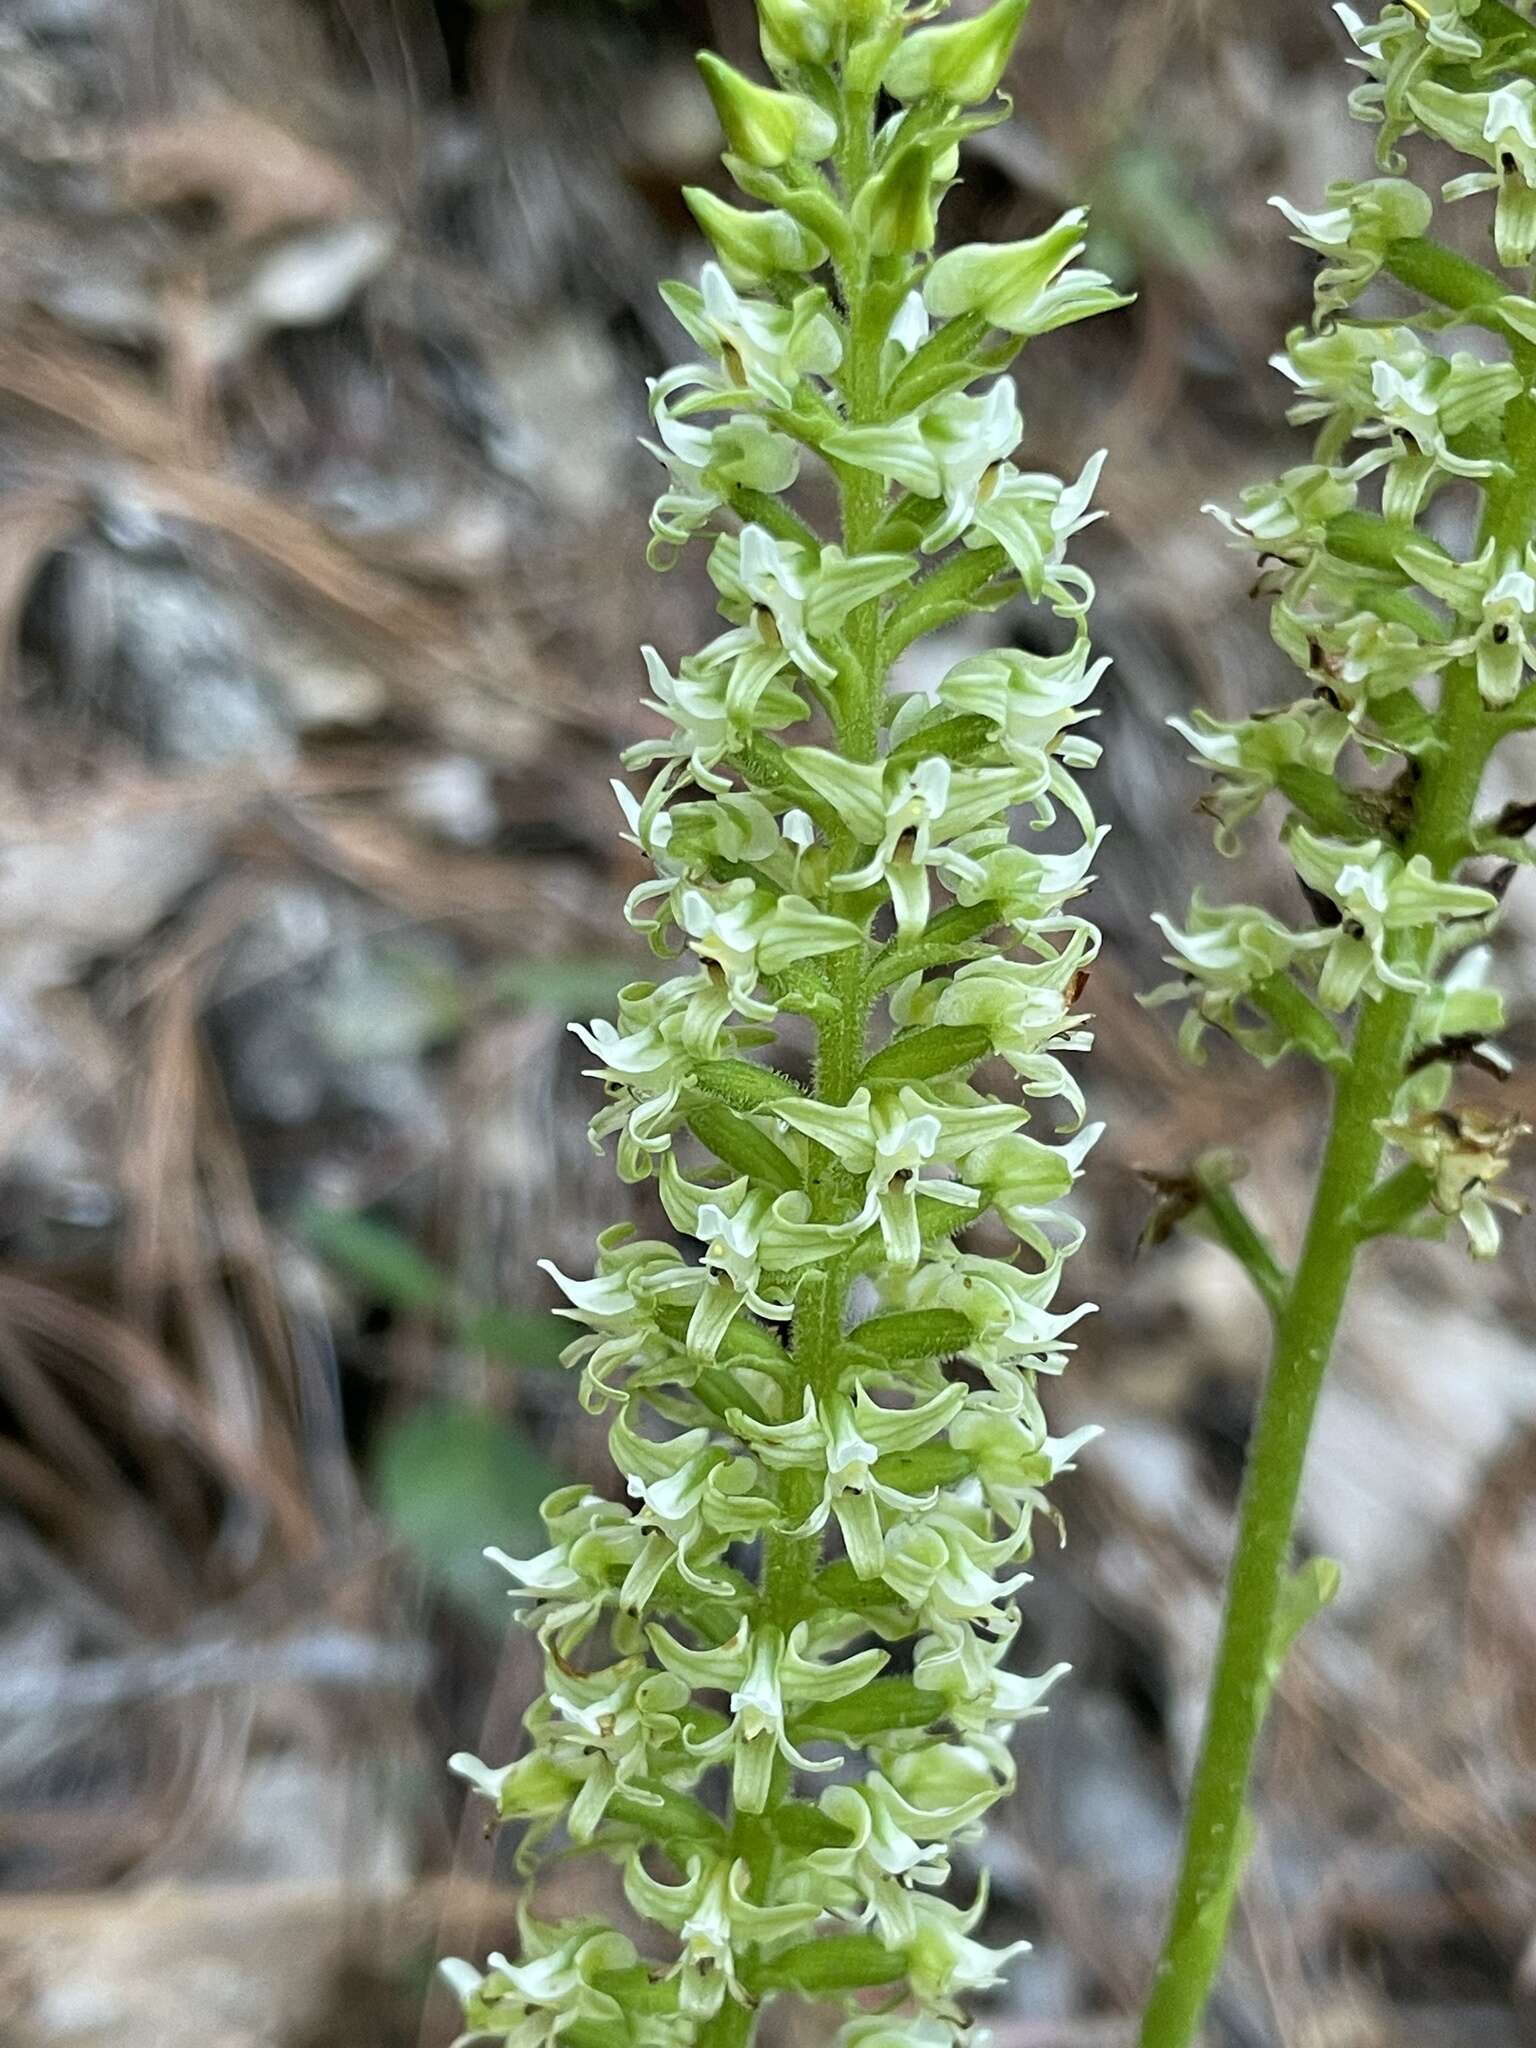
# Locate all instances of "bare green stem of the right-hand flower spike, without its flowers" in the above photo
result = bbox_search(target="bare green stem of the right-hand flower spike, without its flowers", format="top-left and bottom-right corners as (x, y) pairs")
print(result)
(1139, 368), (1536, 2048)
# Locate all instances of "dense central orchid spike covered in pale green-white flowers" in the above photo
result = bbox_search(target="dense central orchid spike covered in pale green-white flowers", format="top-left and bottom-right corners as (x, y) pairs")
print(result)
(438, 0), (1122, 2048)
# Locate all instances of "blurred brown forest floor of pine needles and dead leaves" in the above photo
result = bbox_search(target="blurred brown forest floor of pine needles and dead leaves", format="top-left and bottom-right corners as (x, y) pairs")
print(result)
(0, 0), (1536, 2048)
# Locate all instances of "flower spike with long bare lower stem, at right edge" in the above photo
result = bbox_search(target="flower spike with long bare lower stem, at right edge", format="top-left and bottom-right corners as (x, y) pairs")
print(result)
(1138, 0), (1536, 2048)
